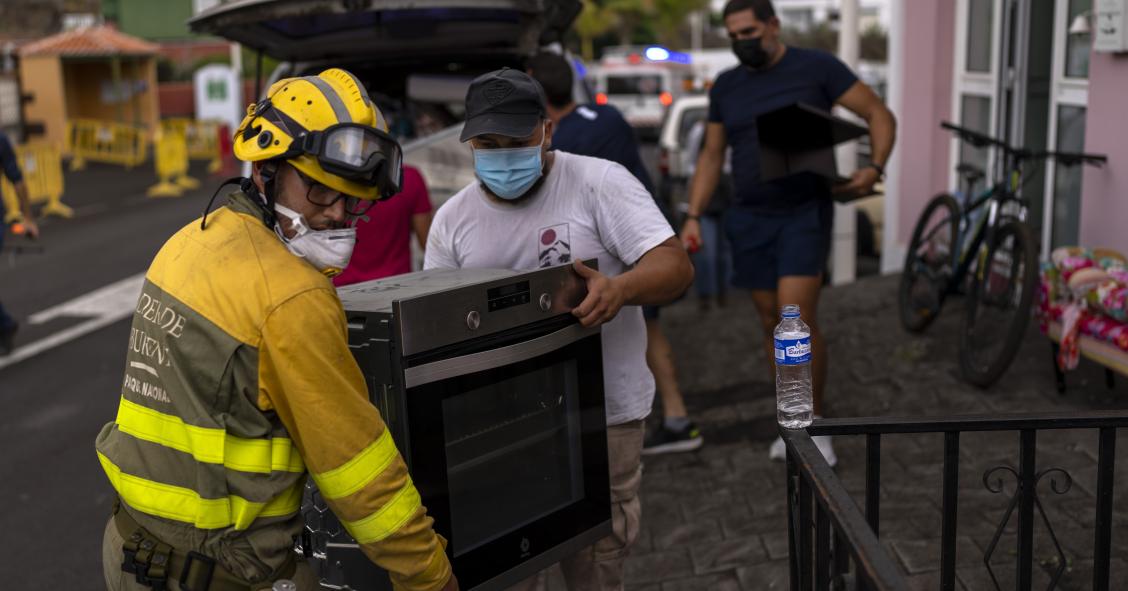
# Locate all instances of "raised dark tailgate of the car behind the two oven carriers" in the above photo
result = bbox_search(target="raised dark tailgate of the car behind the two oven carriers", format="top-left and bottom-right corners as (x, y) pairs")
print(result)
(188, 0), (582, 62)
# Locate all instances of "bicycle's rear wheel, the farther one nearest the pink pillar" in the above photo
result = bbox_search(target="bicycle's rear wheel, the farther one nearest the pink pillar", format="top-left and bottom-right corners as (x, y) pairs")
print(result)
(897, 194), (960, 333)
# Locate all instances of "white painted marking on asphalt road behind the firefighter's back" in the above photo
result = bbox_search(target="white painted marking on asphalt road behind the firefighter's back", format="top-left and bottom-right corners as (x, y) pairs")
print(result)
(0, 273), (144, 369)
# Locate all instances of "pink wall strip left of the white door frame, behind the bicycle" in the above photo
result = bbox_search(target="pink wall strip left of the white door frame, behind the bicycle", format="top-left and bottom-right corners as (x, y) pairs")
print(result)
(885, 0), (955, 247)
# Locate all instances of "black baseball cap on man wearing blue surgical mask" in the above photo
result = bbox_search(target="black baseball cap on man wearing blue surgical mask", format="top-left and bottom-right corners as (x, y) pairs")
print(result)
(459, 68), (546, 142)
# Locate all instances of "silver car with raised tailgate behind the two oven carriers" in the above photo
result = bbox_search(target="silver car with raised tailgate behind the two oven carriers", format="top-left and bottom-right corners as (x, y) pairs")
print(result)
(188, 0), (588, 209)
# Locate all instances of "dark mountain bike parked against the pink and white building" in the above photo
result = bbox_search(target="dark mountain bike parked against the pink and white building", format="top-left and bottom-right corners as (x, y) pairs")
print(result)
(898, 122), (1108, 388)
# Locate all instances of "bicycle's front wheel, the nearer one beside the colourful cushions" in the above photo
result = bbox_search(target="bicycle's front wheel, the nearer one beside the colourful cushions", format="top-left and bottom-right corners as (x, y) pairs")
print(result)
(960, 221), (1038, 388)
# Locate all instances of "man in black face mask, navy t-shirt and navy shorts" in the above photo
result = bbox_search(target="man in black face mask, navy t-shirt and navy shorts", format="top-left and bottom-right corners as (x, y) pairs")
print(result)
(681, 0), (896, 466)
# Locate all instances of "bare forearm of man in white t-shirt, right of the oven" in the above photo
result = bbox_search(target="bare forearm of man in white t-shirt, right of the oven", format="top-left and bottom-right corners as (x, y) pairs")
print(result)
(616, 238), (694, 306)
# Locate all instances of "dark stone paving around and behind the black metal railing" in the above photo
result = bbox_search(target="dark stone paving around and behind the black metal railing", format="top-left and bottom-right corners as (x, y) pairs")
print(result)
(549, 276), (1128, 591)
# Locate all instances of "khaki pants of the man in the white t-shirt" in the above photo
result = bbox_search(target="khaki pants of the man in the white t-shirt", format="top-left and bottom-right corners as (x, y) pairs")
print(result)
(510, 421), (645, 591)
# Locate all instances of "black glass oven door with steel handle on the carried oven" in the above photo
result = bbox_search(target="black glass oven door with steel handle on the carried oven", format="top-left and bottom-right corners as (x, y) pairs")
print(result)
(405, 324), (609, 589)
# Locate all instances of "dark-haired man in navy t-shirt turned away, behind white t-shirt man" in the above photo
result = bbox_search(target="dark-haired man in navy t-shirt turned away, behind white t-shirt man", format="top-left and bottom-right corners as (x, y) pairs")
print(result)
(528, 52), (704, 455)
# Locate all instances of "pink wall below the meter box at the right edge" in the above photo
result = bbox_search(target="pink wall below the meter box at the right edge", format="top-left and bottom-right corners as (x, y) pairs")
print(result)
(1081, 53), (1128, 254)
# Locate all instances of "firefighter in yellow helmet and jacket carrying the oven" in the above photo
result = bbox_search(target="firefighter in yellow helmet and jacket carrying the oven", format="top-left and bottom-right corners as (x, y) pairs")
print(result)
(96, 69), (458, 591)
